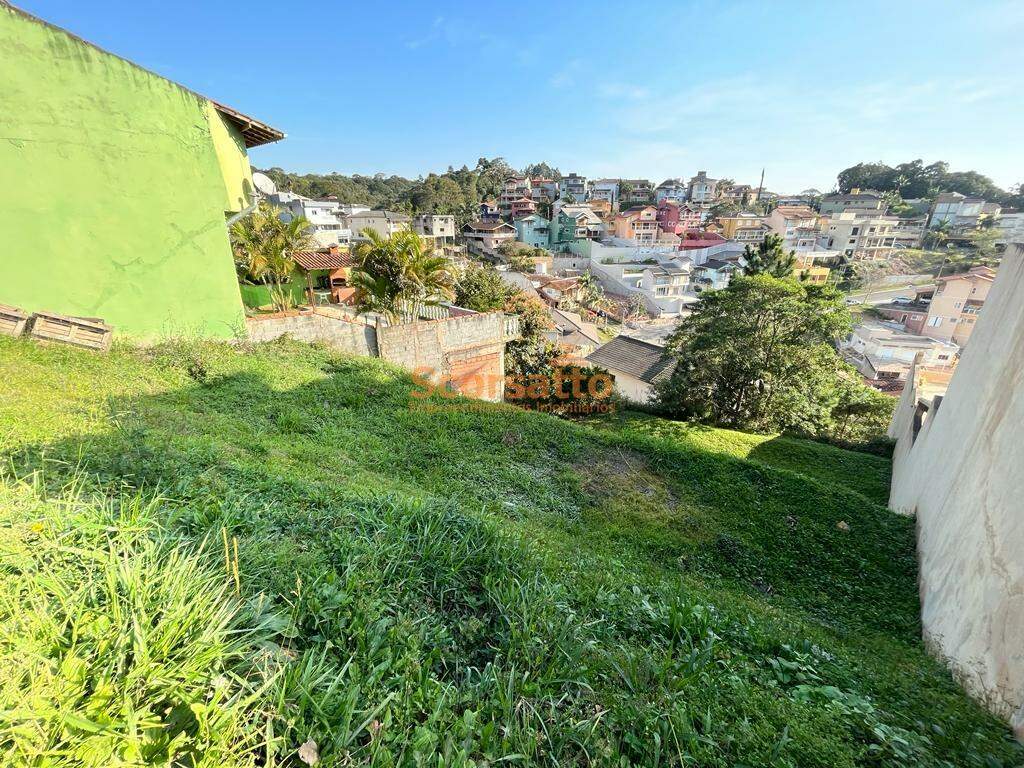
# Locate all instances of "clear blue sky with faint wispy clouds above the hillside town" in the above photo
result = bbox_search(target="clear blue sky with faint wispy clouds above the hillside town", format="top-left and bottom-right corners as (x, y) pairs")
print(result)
(14, 0), (1024, 193)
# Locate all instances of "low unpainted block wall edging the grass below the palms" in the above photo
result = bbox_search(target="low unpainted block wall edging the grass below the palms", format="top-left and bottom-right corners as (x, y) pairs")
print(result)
(246, 307), (505, 400)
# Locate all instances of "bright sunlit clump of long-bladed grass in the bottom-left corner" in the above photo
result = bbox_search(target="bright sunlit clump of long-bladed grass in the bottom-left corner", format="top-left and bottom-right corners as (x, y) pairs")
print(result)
(0, 484), (284, 768)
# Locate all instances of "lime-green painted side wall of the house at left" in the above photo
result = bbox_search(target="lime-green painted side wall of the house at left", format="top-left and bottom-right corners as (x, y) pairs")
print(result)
(0, 4), (248, 339)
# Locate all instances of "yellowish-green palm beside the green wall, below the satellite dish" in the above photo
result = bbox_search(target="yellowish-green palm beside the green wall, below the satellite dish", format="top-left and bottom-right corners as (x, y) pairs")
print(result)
(230, 202), (313, 311)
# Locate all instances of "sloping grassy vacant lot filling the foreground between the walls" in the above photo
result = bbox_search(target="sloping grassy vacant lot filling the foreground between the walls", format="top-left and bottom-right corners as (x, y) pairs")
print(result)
(0, 340), (1024, 768)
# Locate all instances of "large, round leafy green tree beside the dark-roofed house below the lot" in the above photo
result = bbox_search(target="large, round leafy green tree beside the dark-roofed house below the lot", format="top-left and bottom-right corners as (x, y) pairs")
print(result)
(658, 274), (872, 435)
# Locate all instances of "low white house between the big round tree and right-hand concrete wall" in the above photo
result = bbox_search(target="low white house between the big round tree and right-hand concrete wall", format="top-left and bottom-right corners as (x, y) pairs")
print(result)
(839, 322), (959, 381)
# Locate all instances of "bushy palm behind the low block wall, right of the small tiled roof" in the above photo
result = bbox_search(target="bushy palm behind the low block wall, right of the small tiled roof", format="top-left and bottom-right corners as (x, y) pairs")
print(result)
(349, 227), (454, 321)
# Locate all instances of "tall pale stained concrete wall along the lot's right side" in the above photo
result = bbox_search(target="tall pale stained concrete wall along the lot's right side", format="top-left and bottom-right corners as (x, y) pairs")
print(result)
(890, 249), (1024, 737)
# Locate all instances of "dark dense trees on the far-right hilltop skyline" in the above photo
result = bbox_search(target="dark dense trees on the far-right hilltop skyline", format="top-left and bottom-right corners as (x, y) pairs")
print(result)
(837, 160), (1024, 208)
